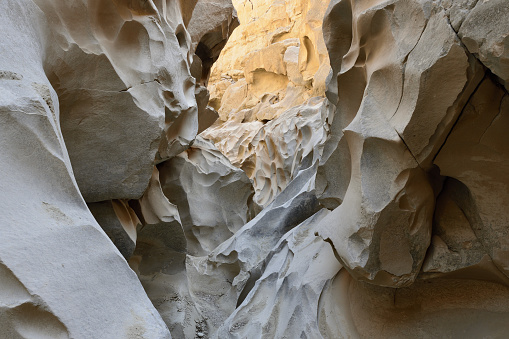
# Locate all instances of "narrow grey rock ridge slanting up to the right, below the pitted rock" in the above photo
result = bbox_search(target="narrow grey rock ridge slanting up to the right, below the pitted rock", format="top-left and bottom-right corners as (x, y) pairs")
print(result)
(186, 162), (319, 333)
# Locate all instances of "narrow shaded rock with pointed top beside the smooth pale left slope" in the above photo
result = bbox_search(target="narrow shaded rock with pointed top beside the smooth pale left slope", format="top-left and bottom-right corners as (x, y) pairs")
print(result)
(129, 168), (194, 338)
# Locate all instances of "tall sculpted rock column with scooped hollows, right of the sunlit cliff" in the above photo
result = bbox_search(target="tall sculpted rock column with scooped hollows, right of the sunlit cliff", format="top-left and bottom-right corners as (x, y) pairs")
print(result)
(320, 1), (490, 286)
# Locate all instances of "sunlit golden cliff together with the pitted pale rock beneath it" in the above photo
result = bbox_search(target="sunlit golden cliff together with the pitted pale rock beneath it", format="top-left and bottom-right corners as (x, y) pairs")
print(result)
(203, 0), (331, 206)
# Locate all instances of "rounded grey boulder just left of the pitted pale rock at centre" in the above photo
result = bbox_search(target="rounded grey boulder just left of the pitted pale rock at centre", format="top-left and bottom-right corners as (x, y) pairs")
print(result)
(159, 137), (256, 256)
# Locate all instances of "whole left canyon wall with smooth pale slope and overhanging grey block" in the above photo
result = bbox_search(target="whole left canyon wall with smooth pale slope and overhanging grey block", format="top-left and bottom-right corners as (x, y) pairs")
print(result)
(0, 0), (236, 338)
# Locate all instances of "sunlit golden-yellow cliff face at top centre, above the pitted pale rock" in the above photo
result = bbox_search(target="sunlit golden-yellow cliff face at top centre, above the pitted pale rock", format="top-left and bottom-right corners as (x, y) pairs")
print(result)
(209, 0), (329, 121)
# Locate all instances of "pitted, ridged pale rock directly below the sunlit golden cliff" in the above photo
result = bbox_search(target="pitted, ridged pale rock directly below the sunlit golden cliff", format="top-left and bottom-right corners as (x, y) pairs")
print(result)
(203, 98), (330, 206)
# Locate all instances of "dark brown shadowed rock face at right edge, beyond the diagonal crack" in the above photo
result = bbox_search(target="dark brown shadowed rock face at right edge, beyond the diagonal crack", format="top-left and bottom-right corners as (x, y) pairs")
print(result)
(435, 77), (509, 277)
